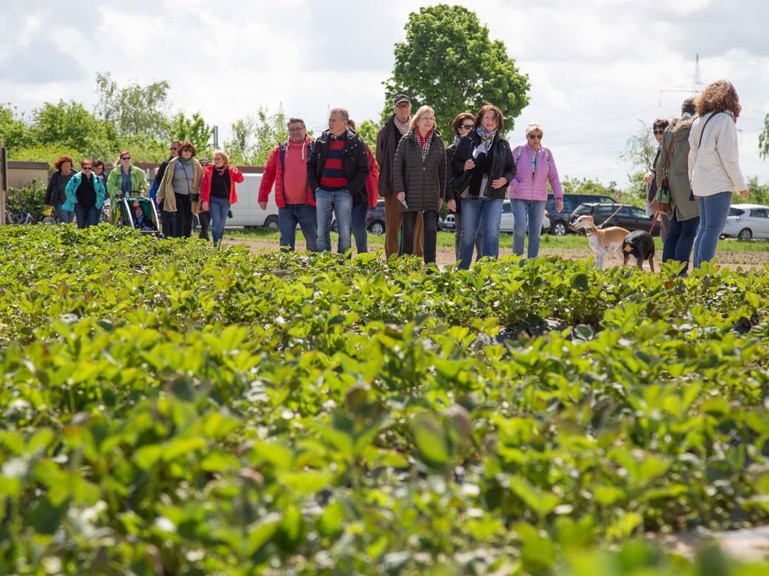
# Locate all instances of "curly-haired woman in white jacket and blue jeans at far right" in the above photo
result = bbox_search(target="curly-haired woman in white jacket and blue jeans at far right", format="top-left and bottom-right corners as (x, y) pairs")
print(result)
(689, 80), (748, 268)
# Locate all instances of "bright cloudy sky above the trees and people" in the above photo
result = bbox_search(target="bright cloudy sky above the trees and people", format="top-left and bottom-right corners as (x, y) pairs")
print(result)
(0, 0), (769, 187)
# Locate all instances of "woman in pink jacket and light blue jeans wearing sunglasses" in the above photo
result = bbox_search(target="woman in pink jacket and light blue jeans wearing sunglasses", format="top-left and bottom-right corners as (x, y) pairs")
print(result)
(509, 122), (563, 258)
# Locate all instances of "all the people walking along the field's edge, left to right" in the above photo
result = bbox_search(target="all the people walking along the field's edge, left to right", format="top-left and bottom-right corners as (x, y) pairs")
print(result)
(45, 81), (747, 270)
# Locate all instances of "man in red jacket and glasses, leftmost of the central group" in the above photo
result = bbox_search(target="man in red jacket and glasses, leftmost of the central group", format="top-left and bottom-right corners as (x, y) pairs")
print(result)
(258, 118), (318, 252)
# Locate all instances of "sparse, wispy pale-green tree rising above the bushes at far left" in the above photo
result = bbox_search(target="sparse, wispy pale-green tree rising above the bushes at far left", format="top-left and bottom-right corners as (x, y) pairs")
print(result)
(96, 72), (170, 145)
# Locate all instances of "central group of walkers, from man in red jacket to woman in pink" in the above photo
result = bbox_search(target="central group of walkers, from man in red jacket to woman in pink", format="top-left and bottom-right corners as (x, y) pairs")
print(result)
(259, 94), (563, 269)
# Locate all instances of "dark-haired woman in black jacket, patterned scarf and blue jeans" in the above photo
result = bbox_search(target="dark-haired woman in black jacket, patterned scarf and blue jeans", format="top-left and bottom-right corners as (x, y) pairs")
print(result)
(451, 104), (515, 270)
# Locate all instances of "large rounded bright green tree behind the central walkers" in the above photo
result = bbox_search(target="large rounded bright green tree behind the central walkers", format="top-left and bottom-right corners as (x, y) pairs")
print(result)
(384, 4), (530, 135)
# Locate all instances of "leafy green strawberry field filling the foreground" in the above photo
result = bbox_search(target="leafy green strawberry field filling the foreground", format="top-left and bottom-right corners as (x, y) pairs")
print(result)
(0, 226), (769, 576)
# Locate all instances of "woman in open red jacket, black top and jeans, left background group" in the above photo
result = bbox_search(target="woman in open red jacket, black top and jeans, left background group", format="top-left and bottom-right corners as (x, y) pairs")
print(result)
(200, 150), (244, 246)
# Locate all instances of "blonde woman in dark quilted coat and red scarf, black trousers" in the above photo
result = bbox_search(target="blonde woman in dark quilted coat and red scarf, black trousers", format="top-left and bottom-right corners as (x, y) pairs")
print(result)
(393, 106), (446, 264)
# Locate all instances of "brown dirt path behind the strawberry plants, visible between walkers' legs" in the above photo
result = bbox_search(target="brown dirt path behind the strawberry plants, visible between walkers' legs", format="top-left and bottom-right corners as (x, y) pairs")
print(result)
(225, 234), (769, 269)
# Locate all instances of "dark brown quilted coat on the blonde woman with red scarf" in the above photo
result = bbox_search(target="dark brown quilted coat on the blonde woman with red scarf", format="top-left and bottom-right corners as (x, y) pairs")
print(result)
(393, 129), (446, 212)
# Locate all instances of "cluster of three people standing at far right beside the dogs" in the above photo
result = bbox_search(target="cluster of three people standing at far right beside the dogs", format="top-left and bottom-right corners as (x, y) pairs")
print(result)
(645, 80), (748, 274)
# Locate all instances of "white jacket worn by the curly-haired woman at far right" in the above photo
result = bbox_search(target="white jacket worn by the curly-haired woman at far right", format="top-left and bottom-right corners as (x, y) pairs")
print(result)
(689, 112), (747, 196)
